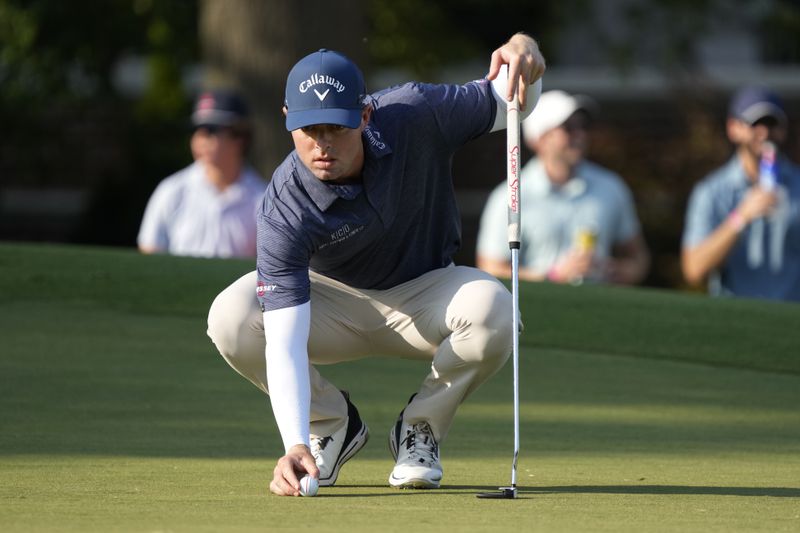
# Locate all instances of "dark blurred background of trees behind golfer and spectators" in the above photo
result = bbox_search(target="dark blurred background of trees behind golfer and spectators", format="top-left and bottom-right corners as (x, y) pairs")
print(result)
(0, 0), (800, 287)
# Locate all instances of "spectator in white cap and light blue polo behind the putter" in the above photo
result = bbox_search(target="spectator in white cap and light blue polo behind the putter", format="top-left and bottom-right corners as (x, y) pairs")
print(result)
(477, 91), (650, 284)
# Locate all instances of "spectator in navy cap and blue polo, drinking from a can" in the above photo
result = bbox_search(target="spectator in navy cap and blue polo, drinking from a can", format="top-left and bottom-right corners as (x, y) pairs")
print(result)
(681, 87), (800, 301)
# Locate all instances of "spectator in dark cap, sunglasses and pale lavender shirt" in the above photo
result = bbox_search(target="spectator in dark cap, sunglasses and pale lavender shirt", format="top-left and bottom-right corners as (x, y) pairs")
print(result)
(138, 90), (266, 257)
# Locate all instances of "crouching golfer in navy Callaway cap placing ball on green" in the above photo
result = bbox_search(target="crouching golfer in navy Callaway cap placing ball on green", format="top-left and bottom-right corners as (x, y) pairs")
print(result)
(208, 33), (544, 496)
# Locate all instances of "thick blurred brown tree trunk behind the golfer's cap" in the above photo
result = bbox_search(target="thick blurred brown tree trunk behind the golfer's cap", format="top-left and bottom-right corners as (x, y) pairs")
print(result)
(200, 0), (367, 178)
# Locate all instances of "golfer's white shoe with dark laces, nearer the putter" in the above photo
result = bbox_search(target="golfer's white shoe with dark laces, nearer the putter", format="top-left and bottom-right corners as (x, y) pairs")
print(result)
(389, 406), (442, 489)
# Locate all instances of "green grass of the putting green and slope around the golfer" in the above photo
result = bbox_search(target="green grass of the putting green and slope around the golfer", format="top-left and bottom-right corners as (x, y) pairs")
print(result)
(0, 244), (800, 532)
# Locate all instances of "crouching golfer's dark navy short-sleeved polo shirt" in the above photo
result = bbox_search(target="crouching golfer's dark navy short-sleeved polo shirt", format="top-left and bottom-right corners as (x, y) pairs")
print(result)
(257, 80), (497, 311)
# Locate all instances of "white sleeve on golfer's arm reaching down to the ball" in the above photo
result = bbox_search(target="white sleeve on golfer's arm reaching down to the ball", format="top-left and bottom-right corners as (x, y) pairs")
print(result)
(264, 302), (311, 451)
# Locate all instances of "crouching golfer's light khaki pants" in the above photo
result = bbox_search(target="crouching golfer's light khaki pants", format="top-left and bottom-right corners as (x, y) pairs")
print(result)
(208, 266), (512, 442)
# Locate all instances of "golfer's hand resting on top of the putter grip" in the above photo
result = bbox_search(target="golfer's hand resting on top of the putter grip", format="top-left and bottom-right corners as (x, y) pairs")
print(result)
(486, 33), (545, 111)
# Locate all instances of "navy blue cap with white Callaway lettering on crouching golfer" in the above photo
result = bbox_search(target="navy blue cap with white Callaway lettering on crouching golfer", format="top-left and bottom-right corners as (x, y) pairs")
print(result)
(285, 48), (367, 131)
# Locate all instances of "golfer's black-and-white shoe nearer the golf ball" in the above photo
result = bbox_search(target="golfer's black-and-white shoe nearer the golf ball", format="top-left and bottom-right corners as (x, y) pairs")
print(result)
(311, 391), (369, 487)
